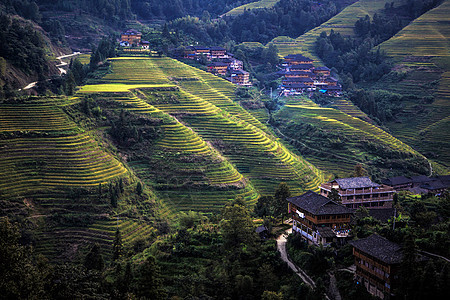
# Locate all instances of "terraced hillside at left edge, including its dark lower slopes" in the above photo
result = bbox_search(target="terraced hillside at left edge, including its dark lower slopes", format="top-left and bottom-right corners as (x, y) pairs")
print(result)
(0, 97), (163, 259)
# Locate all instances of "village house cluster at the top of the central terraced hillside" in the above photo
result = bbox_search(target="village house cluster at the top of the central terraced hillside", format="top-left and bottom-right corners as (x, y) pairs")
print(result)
(183, 46), (252, 86)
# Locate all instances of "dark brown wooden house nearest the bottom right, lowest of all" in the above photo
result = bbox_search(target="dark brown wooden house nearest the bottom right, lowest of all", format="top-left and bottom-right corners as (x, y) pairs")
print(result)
(350, 234), (403, 299)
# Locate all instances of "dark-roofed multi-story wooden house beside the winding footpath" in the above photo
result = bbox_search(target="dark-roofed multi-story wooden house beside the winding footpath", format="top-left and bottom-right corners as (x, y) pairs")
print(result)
(287, 191), (352, 245)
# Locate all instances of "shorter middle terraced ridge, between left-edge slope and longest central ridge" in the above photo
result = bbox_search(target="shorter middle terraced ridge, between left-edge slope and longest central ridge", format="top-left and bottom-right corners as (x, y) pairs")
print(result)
(85, 84), (259, 212)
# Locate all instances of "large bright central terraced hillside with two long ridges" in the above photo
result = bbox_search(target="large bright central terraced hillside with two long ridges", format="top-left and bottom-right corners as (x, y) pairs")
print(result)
(81, 58), (324, 204)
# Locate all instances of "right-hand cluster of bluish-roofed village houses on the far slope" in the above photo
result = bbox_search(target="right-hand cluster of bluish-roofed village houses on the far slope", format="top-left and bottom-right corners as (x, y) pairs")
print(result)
(278, 54), (342, 96)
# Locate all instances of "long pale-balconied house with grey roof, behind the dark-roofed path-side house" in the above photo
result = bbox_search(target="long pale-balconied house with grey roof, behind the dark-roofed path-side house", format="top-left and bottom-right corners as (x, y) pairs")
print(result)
(320, 177), (395, 208)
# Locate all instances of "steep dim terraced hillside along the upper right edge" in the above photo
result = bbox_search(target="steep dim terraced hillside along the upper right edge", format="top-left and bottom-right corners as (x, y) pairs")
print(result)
(379, 1), (450, 167)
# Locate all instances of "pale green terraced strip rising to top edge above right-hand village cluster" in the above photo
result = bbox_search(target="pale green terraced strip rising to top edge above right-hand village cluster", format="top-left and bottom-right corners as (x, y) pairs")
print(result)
(271, 0), (404, 60)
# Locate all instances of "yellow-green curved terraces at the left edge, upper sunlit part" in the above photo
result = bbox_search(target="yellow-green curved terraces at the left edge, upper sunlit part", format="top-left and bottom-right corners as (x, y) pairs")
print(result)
(0, 98), (127, 196)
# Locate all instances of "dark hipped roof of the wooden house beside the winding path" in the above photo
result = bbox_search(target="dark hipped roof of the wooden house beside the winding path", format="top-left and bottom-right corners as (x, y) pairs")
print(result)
(287, 191), (352, 216)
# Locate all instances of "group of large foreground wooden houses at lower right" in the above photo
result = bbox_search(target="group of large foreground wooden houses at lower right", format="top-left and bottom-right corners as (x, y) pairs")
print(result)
(286, 176), (442, 299)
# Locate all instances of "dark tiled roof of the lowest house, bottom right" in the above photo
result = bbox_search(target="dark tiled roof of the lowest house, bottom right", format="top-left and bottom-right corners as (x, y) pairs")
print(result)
(349, 234), (403, 264)
